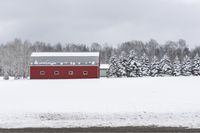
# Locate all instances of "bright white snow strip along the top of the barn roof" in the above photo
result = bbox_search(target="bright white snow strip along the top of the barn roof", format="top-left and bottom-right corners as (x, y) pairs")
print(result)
(31, 52), (99, 57)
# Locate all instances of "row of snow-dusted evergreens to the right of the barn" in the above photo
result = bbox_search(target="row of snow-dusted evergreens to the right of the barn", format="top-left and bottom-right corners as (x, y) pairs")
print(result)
(108, 51), (200, 77)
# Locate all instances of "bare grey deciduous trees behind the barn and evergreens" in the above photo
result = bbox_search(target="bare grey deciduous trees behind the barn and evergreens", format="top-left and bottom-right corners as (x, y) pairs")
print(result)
(0, 39), (200, 79)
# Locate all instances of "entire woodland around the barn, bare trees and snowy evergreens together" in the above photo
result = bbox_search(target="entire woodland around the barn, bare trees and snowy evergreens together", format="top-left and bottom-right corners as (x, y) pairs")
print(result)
(0, 39), (200, 79)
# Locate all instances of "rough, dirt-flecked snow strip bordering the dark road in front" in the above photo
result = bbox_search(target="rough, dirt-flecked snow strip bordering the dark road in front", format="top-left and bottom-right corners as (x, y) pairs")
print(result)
(0, 112), (200, 128)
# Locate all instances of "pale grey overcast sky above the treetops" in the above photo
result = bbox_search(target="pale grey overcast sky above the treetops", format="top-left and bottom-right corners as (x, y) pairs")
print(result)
(0, 0), (200, 47)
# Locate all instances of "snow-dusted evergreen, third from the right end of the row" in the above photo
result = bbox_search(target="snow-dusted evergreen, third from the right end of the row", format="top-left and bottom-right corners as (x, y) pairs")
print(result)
(172, 56), (181, 76)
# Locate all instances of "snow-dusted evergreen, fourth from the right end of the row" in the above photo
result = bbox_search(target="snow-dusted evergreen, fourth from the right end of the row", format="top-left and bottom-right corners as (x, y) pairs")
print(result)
(160, 55), (172, 76)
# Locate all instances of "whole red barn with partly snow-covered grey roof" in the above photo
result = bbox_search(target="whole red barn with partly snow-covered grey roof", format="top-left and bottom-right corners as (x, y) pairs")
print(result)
(30, 52), (100, 79)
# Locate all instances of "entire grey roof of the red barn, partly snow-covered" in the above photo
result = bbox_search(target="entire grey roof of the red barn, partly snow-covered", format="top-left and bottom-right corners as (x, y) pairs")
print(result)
(31, 52), (99, 66)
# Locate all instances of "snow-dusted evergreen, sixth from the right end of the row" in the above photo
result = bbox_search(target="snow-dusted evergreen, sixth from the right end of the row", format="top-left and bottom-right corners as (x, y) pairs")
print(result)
(140, 53), (150, 76)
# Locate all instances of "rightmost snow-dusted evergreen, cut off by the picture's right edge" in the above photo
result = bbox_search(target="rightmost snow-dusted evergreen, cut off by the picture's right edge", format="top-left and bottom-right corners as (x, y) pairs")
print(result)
(192, 54), (200, 76)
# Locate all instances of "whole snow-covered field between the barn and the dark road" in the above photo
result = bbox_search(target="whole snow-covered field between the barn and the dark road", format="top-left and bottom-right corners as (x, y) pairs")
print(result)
(0, 77), (200, 128)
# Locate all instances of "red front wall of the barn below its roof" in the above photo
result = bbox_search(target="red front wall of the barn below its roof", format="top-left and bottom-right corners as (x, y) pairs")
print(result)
(30, 66), (100, 79)
